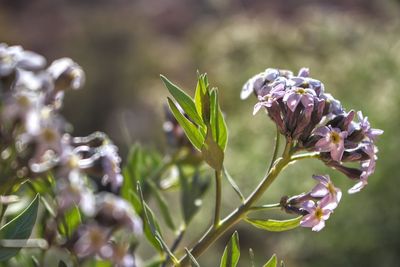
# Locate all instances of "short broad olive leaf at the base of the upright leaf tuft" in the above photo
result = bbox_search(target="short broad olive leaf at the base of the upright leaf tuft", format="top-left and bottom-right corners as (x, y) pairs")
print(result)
(201, 129), (224, 171)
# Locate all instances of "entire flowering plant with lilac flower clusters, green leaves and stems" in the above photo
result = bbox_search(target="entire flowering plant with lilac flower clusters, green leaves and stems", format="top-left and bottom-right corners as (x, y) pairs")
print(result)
(0, 44), (383, 266)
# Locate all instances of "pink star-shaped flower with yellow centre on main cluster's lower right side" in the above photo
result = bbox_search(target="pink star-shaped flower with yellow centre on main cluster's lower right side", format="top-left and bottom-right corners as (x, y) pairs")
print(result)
(314, 126), (347, 162)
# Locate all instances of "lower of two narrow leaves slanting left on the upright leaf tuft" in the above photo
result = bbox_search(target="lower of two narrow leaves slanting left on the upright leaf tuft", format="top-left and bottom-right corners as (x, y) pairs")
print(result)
(168, 98), (204, 150)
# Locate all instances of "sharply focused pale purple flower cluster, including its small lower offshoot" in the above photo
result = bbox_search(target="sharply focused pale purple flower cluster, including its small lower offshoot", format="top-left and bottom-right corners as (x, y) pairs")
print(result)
(241, 68), (383, 231)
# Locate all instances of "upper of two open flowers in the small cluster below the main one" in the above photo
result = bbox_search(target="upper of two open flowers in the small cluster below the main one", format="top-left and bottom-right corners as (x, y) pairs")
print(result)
(310, 175), (342, 210)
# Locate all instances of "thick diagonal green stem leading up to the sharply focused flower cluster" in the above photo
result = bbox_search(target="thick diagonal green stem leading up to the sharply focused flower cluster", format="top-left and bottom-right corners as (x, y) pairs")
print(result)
(180, 140), (292, 266)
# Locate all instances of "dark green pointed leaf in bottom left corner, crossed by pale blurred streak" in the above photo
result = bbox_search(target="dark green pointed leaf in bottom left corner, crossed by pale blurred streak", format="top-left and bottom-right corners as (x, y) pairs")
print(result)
(0, 194), (40, 262)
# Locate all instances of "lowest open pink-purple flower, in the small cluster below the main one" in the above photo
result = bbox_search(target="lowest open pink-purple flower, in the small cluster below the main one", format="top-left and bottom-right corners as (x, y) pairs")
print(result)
(300, 199), (332, 232)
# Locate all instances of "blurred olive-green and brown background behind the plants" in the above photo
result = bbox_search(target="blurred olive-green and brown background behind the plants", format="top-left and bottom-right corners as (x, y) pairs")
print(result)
(0, 0), (400, 267)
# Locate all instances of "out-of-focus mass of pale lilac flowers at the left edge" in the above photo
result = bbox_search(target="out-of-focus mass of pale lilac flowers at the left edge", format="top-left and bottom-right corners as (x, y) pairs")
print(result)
(0, 44), (141, 266)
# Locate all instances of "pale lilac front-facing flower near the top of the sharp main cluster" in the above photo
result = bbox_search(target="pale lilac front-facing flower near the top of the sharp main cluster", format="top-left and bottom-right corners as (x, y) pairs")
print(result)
(283, 87), (316, 113)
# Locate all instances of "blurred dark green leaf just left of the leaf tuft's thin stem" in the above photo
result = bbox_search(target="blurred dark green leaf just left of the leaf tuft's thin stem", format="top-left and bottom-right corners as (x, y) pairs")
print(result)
(179, 169), (210, 225)
